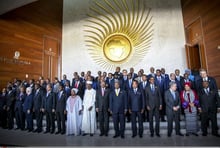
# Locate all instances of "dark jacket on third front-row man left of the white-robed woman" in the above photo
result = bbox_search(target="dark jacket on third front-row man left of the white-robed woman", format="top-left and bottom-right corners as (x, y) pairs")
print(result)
(33, 89), (44, 110)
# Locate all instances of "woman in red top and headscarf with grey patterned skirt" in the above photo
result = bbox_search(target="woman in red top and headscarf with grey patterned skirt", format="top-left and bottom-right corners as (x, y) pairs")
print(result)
(180, 82), (199, 136)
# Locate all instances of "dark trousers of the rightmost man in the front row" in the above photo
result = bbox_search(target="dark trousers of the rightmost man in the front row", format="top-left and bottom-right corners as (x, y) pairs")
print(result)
(201, 111), (218, 134)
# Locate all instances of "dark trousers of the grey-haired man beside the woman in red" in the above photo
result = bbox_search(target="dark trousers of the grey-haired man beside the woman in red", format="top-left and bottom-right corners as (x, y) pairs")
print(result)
(167, 111), (180, 135)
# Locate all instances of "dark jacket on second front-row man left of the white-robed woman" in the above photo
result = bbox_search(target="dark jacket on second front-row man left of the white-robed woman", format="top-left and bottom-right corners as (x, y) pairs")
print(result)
(43, 91), (56, 112)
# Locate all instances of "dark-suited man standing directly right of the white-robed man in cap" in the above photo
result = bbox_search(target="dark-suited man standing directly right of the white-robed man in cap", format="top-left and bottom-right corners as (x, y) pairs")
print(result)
(95, 81), (110, 136)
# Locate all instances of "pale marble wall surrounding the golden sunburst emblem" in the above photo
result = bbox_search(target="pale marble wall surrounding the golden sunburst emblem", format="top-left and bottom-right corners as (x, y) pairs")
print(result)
(62, 0), (187, 78)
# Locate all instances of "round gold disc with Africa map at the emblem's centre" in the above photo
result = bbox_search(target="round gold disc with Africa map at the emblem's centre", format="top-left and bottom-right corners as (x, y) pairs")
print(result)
(103, 34), (132, 62)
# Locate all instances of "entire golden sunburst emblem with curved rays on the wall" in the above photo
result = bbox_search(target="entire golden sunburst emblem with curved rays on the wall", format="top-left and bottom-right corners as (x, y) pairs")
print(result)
(84, 0), (153, 70)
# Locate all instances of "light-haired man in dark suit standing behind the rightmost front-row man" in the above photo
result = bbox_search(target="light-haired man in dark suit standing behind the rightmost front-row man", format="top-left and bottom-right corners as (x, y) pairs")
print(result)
(196, 69), (218, 92)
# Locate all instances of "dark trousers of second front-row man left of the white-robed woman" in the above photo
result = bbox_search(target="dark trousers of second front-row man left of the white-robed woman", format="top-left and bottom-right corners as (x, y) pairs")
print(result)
(46, 111), (55, 132)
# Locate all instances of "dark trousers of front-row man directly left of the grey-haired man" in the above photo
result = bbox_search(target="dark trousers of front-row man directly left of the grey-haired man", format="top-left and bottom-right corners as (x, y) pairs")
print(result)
(149, 107), (160, 134)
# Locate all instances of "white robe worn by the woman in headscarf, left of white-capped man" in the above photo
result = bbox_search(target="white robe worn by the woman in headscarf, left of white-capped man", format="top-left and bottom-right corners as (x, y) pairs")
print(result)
(66, 96), (82, 135)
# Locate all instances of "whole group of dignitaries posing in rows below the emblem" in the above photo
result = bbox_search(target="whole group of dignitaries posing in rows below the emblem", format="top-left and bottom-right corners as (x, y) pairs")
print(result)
(0, 67), (220, 138)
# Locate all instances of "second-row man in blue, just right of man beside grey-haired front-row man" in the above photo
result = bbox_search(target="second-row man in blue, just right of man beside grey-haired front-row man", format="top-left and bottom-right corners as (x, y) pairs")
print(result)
(155, 69), (166, 122)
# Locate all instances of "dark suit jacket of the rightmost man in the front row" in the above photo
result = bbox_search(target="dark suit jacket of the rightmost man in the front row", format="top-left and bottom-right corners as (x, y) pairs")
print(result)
(199, 88), (220, 112)
